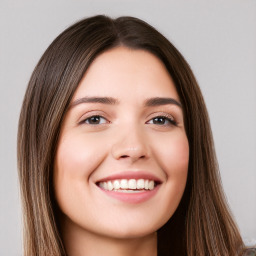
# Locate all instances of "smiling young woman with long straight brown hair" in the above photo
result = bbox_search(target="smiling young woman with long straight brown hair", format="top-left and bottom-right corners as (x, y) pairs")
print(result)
(18, 16), (254, 256)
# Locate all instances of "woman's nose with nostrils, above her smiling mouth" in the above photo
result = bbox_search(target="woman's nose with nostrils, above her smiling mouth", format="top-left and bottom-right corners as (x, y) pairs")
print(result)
(111, 129), (149, 162)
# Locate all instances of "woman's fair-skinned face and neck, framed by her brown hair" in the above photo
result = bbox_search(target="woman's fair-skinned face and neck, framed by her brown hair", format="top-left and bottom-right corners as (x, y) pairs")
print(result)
(54, 47), (189, 256)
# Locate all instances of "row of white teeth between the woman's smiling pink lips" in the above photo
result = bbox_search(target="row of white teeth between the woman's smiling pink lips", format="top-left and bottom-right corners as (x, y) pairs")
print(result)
(99, 179), (155, 193)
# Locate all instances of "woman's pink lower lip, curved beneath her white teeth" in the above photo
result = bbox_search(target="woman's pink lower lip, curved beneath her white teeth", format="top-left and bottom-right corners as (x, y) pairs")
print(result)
(99, 185), (160, 204)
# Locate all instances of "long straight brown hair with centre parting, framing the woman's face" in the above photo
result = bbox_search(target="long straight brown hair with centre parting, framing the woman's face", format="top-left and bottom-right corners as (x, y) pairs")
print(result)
(18, 15), (244, 256)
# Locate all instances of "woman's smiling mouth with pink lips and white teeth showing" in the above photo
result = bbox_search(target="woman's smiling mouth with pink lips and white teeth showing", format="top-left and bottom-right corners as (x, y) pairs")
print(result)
(96, 172), (162, 203)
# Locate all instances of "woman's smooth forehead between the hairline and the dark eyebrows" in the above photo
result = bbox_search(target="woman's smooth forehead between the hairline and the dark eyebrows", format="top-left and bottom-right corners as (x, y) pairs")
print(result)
(74, 47), (179, 100)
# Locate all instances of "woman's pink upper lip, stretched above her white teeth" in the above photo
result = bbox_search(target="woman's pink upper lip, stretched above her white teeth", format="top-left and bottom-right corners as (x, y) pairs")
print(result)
(96, 171), (162, 183)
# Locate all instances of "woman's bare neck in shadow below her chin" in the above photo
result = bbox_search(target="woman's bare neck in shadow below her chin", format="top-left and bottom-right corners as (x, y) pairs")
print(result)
(61, 216), (157, 256)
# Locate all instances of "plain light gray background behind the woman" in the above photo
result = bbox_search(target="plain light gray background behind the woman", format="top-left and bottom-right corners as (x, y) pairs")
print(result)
(0, 0), (256, 256)
